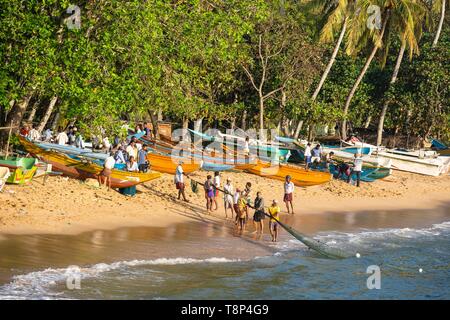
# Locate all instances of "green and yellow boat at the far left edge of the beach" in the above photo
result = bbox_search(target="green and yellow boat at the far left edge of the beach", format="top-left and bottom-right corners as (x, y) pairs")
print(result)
(0, 157), (37, 184)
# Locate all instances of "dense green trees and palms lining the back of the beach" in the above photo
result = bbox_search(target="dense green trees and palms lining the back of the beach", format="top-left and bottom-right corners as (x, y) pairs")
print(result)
(0, 0), (450, 148)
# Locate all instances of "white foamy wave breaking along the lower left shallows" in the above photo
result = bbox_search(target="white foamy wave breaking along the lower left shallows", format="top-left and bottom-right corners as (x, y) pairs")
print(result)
(0, 257), (241, 300)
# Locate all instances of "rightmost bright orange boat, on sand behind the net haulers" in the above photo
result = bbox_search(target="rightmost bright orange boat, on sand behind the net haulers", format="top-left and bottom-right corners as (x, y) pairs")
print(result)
(246, 161), (332, 187)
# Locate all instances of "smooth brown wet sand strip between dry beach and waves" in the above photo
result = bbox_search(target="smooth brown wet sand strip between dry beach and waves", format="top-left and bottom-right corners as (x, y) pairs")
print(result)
(0, 206), (450, 284)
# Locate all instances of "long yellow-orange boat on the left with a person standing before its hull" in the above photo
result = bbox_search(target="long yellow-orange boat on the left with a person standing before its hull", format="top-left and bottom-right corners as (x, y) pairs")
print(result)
(19, 137), (161, 188)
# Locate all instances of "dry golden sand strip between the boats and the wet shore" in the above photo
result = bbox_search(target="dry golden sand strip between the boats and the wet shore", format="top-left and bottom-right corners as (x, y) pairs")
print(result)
(0, 171), (450, 234)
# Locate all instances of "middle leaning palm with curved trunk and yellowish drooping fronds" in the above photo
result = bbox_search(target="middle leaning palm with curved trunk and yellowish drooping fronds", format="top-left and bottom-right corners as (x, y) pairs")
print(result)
(341, 0), (426, 139)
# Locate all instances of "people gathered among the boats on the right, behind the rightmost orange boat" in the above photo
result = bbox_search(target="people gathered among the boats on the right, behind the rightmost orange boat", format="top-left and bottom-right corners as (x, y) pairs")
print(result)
(305, 142), (363, 187)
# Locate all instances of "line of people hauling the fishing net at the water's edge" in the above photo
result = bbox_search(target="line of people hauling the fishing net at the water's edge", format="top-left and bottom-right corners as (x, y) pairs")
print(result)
(174, 162), (294, 242)
